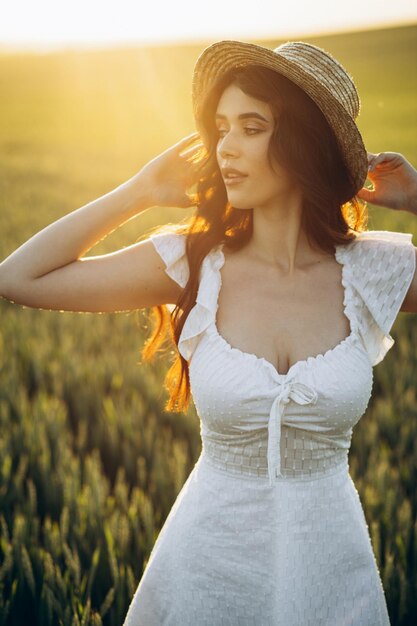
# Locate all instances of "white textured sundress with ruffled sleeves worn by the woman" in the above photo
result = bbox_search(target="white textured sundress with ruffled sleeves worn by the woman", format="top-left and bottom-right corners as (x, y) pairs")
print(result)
(124, 231), (415, 626)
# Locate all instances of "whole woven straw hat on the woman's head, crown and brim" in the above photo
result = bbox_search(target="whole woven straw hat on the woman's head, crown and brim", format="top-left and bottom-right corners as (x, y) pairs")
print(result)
(192, 41), (368, 193)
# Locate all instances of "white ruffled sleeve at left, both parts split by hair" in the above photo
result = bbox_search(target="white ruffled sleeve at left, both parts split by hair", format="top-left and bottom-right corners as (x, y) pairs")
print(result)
(150, 232), (224, 361)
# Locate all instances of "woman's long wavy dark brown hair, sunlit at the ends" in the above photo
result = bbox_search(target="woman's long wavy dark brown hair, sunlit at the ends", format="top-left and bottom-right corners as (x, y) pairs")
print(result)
(142, 66), (367, 412)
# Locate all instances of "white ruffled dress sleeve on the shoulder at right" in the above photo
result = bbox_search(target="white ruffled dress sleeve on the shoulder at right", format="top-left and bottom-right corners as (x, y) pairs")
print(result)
(336, 231), (416, 365)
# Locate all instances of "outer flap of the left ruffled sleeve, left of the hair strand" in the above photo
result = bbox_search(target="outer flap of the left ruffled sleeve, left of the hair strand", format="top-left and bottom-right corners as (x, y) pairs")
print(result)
(150, 232), (190, 288)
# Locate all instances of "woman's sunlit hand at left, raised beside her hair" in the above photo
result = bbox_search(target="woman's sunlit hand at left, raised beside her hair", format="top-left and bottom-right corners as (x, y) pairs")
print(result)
(137, 133), (202, 208)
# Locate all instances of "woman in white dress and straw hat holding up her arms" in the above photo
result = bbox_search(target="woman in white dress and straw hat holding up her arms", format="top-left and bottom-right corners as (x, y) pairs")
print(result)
(0, 42), (417, 626)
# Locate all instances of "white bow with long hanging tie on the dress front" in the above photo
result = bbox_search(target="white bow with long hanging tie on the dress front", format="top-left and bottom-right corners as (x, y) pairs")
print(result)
(268, 382), (317, 486)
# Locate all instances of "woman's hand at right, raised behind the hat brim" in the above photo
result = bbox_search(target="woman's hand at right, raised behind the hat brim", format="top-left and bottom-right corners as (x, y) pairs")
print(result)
(357, 152), (417, 214)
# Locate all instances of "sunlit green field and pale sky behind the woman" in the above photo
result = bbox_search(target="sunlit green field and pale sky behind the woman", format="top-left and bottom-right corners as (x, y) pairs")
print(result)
(0, 0), (417, 626)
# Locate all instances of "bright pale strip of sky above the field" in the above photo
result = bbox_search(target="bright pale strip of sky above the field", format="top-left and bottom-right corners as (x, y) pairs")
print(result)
(0, 0), (417, 50)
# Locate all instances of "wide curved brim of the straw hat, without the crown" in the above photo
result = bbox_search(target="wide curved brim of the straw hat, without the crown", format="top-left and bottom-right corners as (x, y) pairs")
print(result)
(192, 41), (368, 194)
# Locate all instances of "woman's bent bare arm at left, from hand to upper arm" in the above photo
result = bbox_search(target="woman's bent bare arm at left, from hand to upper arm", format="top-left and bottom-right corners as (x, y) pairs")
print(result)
(0, 133), (202, 312)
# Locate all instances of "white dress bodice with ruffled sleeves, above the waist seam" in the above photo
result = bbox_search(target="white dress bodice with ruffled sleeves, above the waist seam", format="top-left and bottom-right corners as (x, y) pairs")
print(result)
(151, 231), (415, 485)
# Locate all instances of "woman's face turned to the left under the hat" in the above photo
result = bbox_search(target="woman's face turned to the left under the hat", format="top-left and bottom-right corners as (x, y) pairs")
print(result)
(216, 84), (294, 209)
